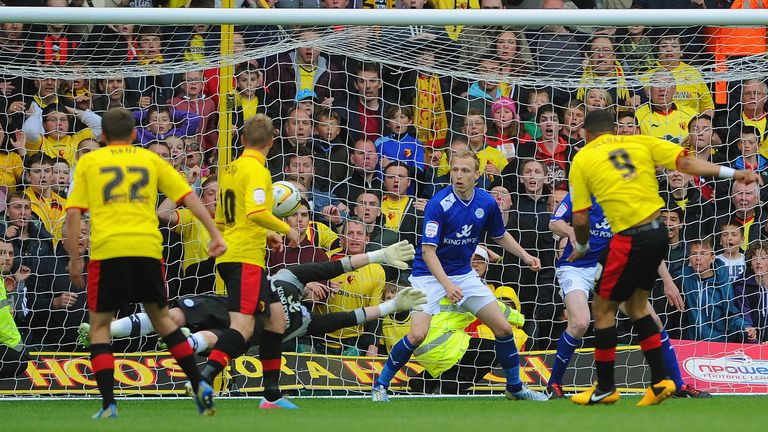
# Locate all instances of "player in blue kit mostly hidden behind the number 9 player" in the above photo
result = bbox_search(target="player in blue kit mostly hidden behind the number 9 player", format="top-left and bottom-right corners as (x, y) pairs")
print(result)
(547, 194), (711, 399)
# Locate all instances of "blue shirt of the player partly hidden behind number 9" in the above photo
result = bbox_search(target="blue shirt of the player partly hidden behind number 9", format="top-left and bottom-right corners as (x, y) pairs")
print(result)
(550, 194), (613, 268)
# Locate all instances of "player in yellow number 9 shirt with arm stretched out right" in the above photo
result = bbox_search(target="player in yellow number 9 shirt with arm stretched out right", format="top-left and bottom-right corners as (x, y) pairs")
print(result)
(568, 110), (758, 406)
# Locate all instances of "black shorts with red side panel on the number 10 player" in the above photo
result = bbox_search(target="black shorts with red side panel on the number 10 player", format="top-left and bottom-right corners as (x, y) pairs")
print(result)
(216, 262), (280, 316)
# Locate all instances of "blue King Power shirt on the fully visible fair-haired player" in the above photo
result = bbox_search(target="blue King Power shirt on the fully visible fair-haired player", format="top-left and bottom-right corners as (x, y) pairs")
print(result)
(412, 186), (506, 276)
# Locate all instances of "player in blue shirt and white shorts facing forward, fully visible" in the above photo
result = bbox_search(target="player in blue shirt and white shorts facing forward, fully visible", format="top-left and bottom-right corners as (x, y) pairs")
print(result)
(371, 150), (547, 402)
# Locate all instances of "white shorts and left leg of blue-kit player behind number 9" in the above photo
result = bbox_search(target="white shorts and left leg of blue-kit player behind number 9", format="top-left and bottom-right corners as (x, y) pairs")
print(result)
(547, 267), (596, 399)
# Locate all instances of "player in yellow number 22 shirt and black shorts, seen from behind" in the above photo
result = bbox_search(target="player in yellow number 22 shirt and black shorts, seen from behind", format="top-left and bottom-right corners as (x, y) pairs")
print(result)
(64, 108), (226, 418)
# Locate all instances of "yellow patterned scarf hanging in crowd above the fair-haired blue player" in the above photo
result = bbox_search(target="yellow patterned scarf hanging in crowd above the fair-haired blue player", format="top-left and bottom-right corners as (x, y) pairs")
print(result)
(414, 74), (448, 147)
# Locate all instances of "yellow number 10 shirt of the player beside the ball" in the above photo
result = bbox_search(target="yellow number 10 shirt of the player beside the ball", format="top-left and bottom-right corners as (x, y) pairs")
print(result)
(216, 149), (272, 268)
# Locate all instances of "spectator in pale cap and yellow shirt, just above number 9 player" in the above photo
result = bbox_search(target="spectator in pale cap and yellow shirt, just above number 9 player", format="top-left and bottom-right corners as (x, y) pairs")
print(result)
(635, 71), (697, 144)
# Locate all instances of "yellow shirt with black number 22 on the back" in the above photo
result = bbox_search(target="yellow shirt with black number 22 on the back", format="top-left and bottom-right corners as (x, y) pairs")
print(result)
(65, 145), (192, 260)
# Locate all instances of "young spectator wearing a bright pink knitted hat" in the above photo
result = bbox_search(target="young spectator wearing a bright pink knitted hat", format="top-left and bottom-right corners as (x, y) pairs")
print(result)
(487, 97), (533, 161)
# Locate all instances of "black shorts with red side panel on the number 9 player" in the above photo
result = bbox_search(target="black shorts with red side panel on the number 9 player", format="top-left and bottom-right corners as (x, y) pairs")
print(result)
(595, 219), (669, 302)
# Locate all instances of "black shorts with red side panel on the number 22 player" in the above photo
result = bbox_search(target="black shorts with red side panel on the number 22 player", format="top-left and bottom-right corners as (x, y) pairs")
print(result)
(88, 257), (168, 312)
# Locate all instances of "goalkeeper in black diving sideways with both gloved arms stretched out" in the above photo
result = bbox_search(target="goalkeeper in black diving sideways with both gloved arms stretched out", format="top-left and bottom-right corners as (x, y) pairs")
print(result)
(78, 241), (426, 353)
